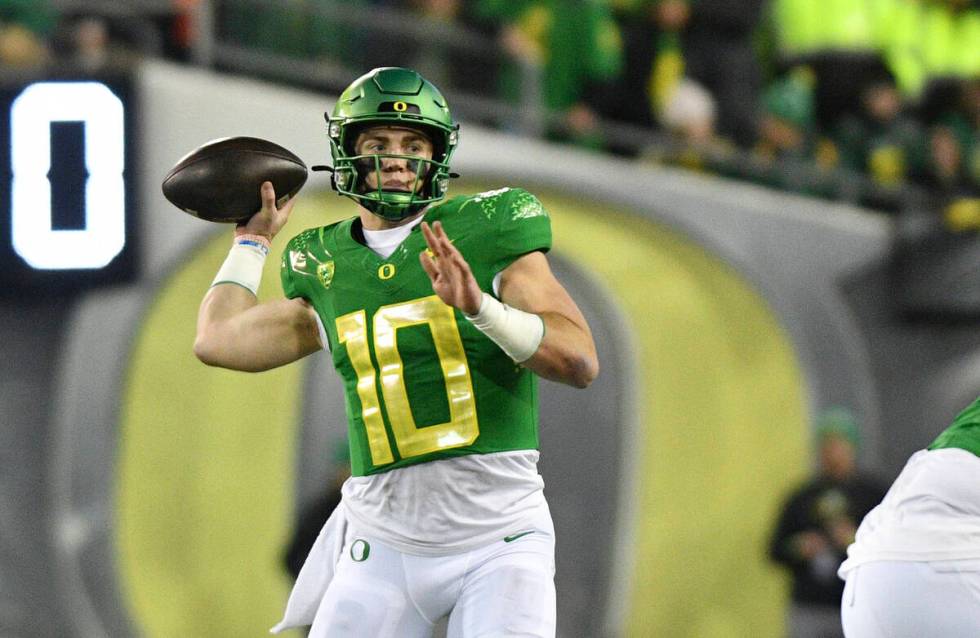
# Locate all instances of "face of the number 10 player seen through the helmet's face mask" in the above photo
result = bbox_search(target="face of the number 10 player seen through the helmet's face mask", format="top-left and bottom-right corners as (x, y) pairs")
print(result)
(354, 126), (432, 192)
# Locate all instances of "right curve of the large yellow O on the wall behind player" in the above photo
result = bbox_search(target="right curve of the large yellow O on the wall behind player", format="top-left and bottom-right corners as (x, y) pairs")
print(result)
(546, 200), (810, 638)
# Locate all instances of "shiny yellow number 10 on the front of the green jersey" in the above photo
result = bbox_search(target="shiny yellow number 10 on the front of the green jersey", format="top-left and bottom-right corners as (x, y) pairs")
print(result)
(337, 295), (480, 465)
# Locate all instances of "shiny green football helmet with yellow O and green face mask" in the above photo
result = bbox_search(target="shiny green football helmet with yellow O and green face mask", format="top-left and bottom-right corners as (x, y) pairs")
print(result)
(325, 67), (459, 221)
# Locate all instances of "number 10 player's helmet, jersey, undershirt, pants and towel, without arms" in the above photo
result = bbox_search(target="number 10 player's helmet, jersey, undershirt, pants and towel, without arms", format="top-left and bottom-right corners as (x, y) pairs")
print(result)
(275, 67), (568, 636)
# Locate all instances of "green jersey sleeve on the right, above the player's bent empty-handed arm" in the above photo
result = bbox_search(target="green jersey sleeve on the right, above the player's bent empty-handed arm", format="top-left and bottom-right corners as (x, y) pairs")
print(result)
(494, 188), (551, 272)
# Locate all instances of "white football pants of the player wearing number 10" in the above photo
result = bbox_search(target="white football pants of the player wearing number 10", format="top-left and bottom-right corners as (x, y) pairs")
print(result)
(310, 508), (556, 638)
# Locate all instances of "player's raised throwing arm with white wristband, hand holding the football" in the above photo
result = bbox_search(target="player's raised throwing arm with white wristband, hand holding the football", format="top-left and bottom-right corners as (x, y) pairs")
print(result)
(188, 182), (322, 372)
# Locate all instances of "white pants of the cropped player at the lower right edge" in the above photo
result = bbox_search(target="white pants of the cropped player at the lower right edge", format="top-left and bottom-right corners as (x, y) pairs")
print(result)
(841, 560), (980, 638)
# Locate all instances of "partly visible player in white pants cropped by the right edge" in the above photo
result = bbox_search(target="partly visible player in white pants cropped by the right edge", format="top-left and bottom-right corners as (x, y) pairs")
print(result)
(839, 399), (980, 638)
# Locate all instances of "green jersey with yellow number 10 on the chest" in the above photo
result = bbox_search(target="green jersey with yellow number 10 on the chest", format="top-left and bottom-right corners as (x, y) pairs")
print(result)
(281, 188), (551, 476)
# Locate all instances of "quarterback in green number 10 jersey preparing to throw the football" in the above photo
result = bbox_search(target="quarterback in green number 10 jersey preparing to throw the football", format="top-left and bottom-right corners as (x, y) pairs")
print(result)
(194, 67), (598, 638)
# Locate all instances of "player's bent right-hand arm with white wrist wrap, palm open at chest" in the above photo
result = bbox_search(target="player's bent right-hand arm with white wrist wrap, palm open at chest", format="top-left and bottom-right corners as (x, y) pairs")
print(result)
(420, 222), (599, 388)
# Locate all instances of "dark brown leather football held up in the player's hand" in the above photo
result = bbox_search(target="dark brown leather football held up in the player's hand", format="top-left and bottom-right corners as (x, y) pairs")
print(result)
(163, 137), (308, 224)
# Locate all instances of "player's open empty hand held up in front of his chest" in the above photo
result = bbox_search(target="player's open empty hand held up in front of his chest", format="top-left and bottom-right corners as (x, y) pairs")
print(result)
(419, 222), (483, 315)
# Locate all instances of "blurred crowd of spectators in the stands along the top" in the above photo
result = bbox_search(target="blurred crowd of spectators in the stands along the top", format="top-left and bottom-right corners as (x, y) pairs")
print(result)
(0, 0), (980, 221)
